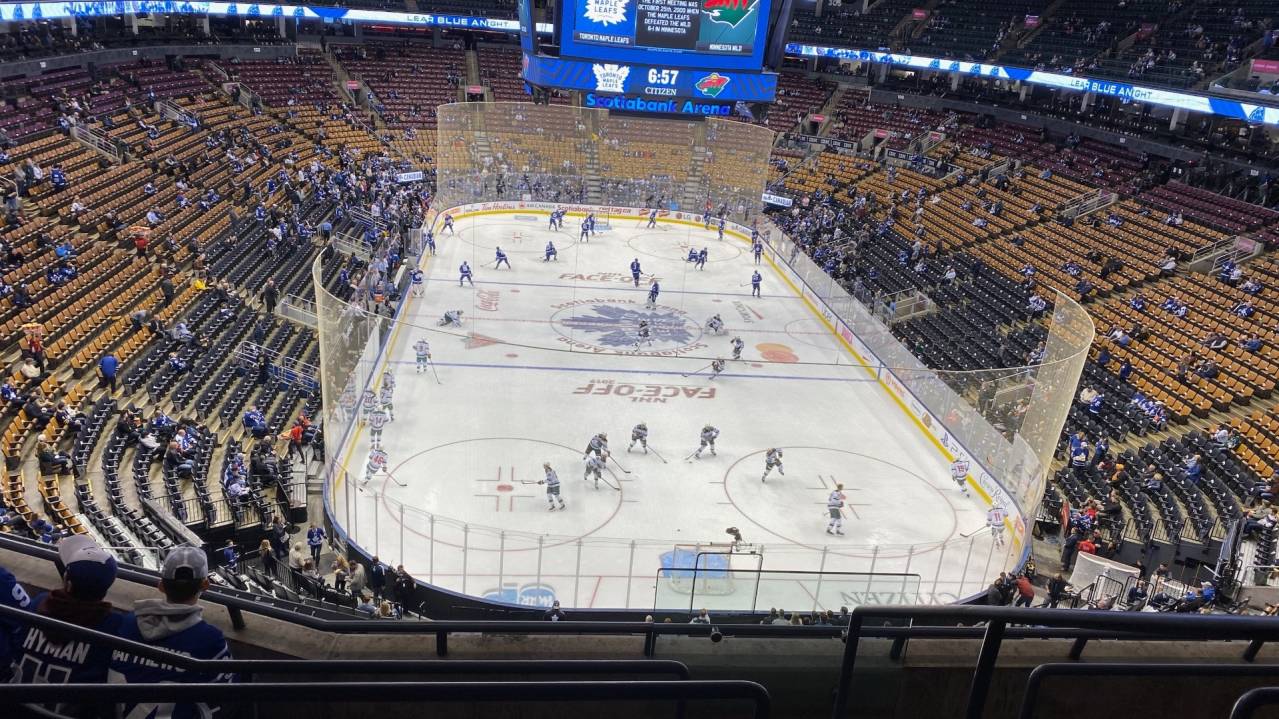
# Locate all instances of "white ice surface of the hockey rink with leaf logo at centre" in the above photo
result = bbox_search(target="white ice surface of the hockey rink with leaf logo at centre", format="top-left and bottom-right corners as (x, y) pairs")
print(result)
(335, 211), (1013, 612)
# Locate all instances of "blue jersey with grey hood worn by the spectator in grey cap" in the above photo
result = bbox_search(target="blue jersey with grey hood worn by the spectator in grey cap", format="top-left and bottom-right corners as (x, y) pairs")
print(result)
(109, 599), (235, 719)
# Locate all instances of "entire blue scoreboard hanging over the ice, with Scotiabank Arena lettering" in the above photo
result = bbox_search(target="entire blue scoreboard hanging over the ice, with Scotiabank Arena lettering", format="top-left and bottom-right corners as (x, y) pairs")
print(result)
(519, 0), (777, 109)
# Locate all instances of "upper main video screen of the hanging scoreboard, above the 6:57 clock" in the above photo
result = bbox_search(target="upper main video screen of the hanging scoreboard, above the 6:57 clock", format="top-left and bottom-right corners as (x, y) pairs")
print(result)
(559, 0), (773, 72)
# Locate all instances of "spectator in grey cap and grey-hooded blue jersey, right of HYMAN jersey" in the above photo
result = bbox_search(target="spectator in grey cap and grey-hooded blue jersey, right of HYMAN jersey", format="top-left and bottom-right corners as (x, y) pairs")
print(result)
(110, 546), (235, 719)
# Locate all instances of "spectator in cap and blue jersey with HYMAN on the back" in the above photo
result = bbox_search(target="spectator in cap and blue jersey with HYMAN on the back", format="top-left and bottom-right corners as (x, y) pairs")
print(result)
(14, 535), (120, 718)
